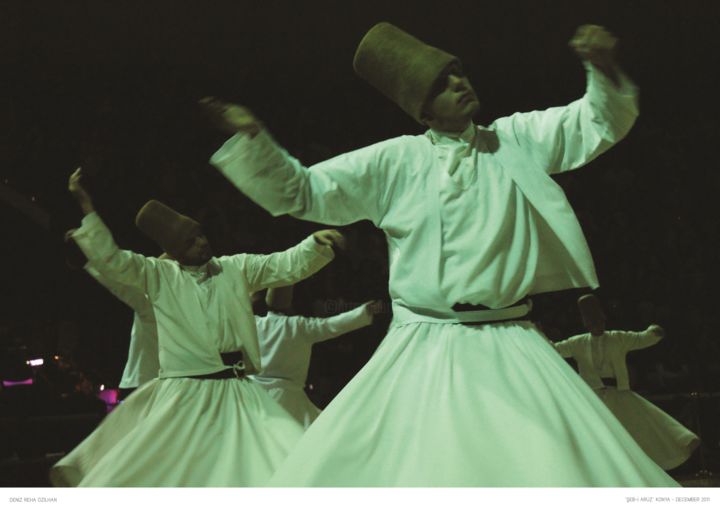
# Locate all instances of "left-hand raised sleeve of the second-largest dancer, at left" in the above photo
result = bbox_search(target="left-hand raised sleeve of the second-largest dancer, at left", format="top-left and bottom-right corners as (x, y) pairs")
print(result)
(72, 212), (160, 298)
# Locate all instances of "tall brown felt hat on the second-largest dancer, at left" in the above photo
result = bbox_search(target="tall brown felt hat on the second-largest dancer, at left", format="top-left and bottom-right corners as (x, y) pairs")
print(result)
(135, 200), (200, 257)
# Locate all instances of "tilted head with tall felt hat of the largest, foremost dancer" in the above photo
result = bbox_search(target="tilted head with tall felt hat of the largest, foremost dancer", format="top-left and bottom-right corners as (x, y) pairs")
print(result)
(353, 22), (480, 132)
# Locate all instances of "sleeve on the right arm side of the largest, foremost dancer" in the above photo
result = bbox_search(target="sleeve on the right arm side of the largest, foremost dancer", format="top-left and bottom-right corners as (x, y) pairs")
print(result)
(495, 64), (638, 173)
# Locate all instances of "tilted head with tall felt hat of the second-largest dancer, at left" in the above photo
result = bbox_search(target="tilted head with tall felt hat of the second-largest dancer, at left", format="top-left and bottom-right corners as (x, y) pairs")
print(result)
(135, 200), (212, 266)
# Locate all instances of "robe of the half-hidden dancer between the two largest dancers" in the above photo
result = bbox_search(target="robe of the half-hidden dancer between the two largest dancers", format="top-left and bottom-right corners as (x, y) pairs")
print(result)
(250, 305), (373, 428)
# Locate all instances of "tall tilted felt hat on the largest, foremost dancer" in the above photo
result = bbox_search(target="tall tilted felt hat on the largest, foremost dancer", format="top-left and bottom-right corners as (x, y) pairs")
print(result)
(353, 22), (460, 122)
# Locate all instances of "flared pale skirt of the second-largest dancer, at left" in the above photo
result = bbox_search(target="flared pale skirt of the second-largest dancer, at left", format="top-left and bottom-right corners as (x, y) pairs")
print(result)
(50, 372), (303, 487)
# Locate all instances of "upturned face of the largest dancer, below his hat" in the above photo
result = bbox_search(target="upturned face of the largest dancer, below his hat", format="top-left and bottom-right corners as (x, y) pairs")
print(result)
(422, 64), (480, 132)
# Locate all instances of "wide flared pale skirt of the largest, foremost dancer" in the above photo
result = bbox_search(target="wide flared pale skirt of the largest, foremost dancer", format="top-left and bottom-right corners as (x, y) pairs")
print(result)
(269, 322), (678, 487)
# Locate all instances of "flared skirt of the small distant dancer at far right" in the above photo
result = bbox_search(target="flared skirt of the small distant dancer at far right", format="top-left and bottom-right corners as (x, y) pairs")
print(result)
(596, 387), (700, 469)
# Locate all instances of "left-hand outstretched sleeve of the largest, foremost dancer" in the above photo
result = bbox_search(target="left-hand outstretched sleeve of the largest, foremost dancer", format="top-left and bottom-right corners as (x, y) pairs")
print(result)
(205, 131), (387, 226)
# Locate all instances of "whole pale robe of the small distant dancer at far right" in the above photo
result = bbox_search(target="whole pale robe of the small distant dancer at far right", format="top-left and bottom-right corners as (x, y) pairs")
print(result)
(555, 329), (700, 469)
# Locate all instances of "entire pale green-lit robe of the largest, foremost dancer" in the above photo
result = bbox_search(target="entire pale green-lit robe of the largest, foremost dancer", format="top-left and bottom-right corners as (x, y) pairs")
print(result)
(211, 64), (676, 486)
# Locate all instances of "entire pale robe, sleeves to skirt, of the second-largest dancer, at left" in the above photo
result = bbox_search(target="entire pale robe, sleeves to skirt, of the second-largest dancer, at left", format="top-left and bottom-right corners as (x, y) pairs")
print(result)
(50, 213), (333, 487)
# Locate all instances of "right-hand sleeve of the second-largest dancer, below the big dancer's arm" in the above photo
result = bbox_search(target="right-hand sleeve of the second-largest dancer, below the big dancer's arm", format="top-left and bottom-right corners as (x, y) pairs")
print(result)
(227, 236), (335, 293)
